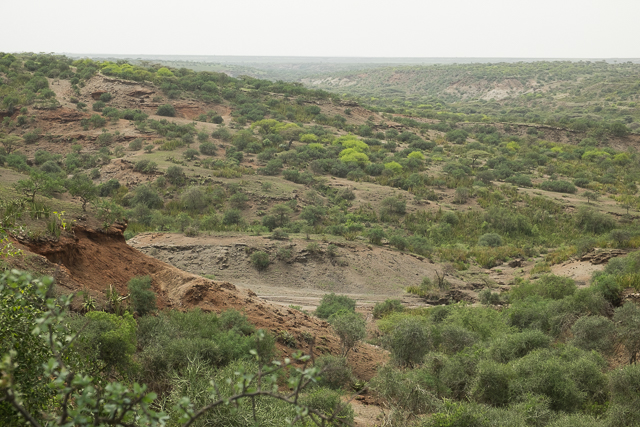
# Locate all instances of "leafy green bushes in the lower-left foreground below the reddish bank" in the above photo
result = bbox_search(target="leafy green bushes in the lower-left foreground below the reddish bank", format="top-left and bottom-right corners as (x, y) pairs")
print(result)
(0, 270), (353, 427)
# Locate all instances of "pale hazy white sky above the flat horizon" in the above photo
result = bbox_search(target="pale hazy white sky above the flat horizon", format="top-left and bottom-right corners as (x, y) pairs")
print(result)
(0, 0), (640, 58)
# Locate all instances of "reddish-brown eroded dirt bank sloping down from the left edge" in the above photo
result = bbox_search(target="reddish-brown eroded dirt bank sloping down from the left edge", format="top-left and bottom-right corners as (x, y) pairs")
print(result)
(12, 225), (387, 380)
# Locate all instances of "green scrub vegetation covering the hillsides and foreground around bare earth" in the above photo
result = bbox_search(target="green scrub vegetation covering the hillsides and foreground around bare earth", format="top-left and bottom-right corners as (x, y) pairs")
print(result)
(0, 53), (640, 426)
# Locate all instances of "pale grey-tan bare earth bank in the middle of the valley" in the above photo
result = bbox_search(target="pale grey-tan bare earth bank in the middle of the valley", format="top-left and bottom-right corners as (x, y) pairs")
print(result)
(128, 233), (462, 309)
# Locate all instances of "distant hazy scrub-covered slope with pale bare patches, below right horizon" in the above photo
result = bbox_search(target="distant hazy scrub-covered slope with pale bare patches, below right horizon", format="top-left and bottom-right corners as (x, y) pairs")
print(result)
(302, 61), (640, 135)
